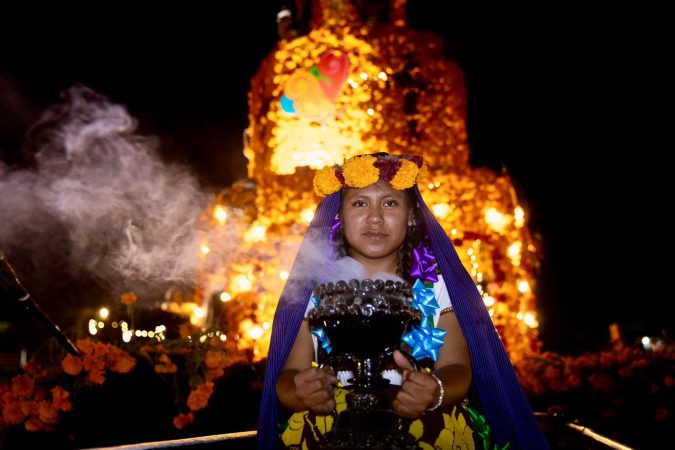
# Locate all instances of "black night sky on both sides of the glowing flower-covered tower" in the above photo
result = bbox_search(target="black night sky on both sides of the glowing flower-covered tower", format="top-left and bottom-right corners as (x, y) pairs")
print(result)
(0, 1), (673, 351)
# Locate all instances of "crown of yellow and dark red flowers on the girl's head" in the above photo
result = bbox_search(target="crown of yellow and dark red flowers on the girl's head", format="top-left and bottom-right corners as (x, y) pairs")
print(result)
(314, 153), (427, 197)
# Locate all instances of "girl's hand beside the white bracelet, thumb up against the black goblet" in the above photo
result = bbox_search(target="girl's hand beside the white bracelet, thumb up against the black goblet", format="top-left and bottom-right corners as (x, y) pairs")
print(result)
(392, 350), (440, 419)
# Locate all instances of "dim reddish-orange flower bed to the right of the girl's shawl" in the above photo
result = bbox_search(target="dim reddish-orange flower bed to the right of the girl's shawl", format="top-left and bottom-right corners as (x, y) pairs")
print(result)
(516, 345), (675, 423)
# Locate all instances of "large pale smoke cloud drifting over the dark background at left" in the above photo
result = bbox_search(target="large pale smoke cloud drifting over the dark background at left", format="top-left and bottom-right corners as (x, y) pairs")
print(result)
(0, 85), (239, 302)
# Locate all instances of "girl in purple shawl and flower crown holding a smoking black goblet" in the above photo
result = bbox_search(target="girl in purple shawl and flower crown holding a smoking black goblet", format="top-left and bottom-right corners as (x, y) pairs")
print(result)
(258, 153), (548, 449)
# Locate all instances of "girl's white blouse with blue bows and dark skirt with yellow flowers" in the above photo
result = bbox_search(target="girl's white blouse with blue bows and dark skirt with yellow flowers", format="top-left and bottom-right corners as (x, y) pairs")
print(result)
(279, 274), (508, 450)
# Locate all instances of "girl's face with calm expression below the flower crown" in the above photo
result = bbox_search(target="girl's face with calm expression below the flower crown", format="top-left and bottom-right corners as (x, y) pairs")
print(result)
(342, 180), (414, 271)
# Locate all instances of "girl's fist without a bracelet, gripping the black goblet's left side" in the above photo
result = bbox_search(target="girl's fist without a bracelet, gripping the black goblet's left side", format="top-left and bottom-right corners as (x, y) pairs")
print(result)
(293, 367), (337, 414)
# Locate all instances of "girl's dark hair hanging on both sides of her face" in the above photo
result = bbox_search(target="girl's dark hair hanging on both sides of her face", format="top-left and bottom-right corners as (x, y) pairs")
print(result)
(333, 188), (422, 283)
